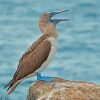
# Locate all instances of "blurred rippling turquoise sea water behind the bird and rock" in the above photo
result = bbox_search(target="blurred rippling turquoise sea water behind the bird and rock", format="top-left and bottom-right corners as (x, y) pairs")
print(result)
(0, 0), (100, 100)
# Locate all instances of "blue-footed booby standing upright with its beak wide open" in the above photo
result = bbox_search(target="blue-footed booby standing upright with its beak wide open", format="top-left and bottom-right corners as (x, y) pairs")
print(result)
(2, 10), (69, 97)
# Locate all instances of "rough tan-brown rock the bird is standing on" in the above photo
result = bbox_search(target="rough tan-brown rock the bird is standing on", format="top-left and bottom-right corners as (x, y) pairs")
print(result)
(27, 78), (100, 100)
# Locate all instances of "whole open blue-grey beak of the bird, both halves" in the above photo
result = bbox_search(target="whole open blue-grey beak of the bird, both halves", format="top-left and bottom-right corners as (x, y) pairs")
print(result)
(49, 10), (70, 25)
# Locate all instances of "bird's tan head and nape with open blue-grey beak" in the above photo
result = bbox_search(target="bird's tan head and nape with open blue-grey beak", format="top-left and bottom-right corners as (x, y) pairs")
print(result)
(39, 10), (69, 33)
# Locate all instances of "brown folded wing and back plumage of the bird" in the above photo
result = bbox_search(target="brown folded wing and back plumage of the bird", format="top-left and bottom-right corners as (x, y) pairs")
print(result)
(5, 34), (51, 94)
